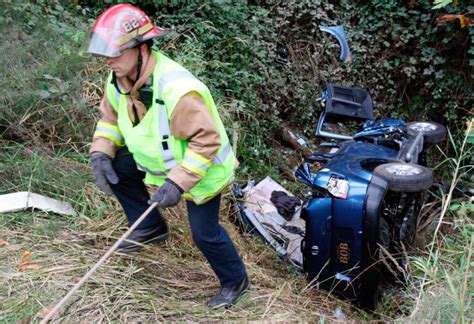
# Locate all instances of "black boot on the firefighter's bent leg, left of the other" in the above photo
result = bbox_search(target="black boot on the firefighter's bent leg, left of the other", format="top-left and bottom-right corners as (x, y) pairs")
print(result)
(117, 222), (170, 253)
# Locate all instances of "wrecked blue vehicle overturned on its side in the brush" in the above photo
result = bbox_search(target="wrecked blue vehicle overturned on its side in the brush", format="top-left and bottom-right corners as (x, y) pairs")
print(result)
(236, 84), (446, 309)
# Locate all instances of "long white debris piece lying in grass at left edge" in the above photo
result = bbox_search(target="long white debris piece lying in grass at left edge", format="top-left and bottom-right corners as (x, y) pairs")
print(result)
(0, 191), (76, 216)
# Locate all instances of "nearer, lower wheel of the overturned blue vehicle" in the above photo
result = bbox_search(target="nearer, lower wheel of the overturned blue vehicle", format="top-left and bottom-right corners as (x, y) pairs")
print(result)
(374, 162), (433, 192)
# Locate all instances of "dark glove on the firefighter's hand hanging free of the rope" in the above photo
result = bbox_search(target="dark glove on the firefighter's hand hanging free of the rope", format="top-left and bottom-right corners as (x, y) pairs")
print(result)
(91, 152), (119, 196)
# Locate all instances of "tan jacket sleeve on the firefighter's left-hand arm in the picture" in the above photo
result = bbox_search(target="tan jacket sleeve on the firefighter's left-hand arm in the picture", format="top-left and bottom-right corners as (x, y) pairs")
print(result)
(89, 96), (117, 158)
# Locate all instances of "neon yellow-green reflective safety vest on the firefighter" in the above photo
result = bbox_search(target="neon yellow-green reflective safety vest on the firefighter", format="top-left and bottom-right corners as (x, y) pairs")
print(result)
(105, 52), (236, 204)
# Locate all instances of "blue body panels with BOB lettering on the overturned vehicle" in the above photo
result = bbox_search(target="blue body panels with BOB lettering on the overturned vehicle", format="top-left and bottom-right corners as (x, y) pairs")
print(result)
(303, 142), (399, 299)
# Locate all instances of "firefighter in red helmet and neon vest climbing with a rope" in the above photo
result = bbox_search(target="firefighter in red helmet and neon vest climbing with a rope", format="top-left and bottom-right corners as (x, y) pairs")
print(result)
(88, 4), (249, 308)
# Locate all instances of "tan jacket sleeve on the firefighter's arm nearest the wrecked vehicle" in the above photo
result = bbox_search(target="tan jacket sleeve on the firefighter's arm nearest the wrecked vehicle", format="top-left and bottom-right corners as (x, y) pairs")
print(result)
(168, 92), (221, 191)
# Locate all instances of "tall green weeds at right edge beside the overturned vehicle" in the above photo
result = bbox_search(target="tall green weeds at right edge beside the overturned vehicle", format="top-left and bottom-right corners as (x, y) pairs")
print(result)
(410, 120), (474, 323)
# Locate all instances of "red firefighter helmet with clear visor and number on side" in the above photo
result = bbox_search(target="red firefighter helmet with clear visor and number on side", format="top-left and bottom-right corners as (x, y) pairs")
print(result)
(87, 4), (167, 57)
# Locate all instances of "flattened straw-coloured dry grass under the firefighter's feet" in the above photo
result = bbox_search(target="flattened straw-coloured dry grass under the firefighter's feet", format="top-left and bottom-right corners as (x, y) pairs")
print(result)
(0, 187), (351, 322)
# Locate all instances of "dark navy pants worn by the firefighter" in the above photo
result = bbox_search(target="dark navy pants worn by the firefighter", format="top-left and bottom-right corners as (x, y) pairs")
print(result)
(110, 147), (246, 287)
